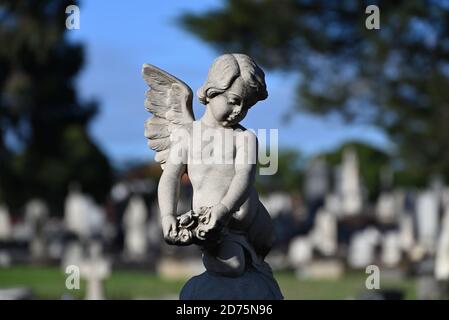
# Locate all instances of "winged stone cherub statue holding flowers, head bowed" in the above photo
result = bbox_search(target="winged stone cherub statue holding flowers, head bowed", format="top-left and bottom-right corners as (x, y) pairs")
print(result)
(142, 54), (282, 299)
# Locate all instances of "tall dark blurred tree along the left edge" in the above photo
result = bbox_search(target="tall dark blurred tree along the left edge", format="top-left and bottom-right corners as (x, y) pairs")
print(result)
(0, 0), (111, 215)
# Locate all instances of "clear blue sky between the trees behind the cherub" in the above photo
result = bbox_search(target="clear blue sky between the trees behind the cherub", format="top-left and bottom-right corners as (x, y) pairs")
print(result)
(69, 0), (388, 163)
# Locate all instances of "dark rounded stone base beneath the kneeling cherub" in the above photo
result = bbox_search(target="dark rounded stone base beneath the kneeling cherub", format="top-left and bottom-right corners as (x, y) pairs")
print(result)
(179, 269), (284, 300)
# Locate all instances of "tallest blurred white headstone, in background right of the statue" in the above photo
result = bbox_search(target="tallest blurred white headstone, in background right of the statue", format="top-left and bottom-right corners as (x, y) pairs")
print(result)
(340, 149), (362, 215)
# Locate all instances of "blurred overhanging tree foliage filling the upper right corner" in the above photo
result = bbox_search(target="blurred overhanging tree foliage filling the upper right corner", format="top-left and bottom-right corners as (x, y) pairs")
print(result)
(180, 0), (449, 183)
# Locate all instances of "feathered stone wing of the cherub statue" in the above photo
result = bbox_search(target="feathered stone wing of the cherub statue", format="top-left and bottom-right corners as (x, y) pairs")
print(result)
(142, 64), (195, 169)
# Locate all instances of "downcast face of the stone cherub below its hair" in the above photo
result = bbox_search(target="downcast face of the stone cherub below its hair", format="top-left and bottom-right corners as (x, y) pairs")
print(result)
(208, 77), (248, 127)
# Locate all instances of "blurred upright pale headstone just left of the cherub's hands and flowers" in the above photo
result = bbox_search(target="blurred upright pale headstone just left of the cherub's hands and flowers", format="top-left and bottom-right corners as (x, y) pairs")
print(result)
(123, 196), (148, 259)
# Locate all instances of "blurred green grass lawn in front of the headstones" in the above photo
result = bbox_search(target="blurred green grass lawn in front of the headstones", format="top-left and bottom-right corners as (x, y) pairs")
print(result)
(0, 266), (416, 299)
